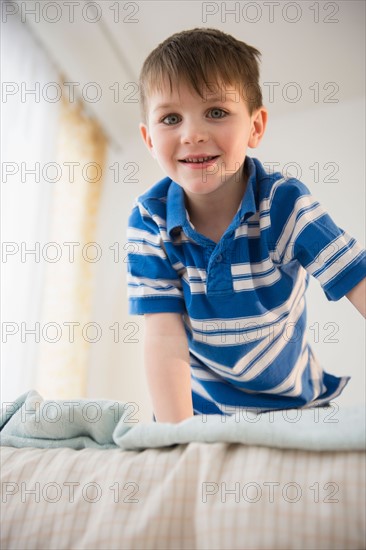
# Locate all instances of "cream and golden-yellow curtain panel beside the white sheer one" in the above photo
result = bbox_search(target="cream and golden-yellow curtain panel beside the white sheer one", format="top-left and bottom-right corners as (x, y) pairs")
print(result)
(36, 94), (107, 399)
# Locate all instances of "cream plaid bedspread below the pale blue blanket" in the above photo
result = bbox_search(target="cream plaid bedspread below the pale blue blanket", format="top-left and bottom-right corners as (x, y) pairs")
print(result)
(1, 442), (366, 550)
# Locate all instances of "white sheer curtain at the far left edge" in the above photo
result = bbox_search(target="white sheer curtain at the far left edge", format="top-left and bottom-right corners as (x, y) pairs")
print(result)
(1, 11), (60, 401)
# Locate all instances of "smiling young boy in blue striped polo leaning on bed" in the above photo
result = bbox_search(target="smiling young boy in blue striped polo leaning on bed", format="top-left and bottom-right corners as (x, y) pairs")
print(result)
(128, 29), (366, 422)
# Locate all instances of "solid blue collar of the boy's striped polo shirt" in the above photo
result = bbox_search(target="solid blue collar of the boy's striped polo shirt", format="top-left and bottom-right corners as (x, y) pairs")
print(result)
(167, 157), (257, 234)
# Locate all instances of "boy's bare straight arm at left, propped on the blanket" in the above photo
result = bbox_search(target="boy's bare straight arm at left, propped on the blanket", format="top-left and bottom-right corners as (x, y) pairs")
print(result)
(144, 313), (193, 422)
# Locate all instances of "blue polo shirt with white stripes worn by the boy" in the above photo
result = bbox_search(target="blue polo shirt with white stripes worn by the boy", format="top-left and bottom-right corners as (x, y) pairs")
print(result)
(127, 157), (366, 415)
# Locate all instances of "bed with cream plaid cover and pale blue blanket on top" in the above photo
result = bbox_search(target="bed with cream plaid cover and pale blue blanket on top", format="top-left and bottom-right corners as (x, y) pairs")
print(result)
(1, 394), (366, 550)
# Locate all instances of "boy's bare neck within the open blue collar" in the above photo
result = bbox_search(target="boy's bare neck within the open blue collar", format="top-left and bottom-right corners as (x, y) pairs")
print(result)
(185, 160), (248, 240)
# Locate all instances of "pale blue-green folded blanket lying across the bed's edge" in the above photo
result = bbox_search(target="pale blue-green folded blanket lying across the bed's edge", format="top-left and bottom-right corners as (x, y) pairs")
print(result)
(0, 390), (366, 451)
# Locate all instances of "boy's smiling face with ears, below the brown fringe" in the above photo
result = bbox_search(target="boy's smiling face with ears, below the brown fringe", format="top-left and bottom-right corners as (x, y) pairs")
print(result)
(140, 83), (266, 200)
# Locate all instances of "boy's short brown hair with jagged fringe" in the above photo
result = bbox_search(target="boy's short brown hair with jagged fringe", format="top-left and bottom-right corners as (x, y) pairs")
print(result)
(139, 28), (262, 124)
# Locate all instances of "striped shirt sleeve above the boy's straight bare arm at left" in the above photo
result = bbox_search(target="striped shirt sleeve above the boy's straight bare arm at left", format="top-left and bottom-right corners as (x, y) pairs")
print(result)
(126, 201), (185, 315)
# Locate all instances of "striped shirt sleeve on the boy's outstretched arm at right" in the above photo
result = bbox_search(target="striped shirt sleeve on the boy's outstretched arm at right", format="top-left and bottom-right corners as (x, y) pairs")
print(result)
(270, 179), (366, 301)
